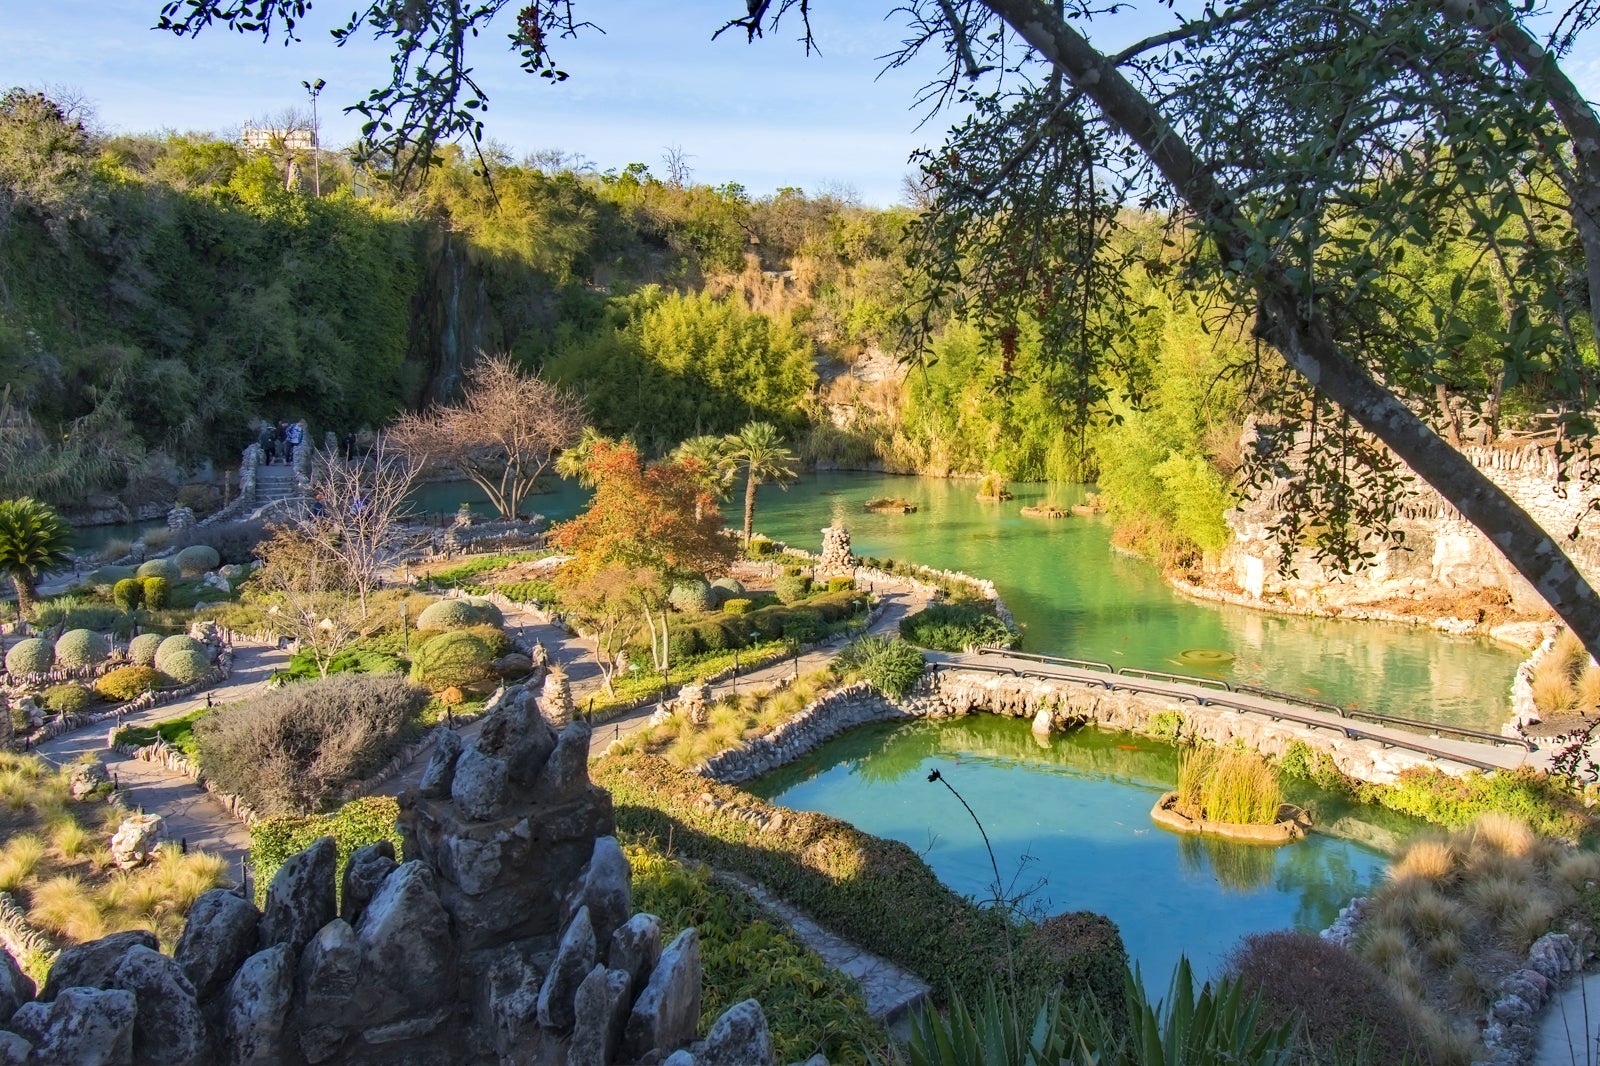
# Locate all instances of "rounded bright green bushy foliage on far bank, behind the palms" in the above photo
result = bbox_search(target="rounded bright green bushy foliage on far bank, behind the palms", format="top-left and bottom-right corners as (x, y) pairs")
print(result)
(546, 287), (816, 450)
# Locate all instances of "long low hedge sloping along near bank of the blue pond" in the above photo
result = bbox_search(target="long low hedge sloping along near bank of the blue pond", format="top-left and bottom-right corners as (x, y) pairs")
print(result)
(594, 754), (1126, 1010)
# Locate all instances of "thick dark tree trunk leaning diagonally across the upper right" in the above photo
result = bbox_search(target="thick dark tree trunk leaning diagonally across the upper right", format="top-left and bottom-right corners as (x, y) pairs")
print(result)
(982, 0), (1600, 655)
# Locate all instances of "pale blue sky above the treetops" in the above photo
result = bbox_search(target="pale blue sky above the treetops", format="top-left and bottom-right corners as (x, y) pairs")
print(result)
(0, 0), (1600, 205)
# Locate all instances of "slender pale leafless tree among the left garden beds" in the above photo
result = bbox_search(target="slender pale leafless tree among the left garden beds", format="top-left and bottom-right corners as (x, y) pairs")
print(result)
(294, 439), (422, 621)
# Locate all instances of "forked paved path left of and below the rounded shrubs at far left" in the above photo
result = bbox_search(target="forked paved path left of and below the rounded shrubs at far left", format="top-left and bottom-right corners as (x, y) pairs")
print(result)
(34, 645), (290, 879)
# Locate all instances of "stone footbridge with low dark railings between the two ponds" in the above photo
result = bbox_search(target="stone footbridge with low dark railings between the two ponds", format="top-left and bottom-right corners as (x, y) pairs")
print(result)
(926, 648), (1554, 779)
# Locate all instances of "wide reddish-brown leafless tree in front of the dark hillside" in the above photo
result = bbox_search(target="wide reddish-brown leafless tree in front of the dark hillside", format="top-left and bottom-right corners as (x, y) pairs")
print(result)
(389, 355), (584, 519)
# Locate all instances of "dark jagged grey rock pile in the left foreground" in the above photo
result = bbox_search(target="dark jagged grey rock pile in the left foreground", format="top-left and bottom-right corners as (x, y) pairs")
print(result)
(0, 688), (773, 1066)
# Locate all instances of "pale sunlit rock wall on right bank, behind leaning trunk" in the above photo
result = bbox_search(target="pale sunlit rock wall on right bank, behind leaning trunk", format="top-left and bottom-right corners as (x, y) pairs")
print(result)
(1218, 429), (1600, 623)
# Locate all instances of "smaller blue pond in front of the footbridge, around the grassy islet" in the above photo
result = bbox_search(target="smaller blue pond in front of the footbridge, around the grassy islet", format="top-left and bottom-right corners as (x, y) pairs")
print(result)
(746, 714), (1421, 988)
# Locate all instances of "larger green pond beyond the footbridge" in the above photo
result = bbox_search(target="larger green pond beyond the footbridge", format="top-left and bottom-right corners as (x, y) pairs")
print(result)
(406, 472), (1522, 730)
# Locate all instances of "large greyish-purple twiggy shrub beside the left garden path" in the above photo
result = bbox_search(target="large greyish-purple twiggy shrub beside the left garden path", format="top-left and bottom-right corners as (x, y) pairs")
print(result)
(195, 674), (427, 815)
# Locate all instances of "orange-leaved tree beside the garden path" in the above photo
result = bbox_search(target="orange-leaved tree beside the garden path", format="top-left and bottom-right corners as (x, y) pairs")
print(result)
(550, 439), (734, 674)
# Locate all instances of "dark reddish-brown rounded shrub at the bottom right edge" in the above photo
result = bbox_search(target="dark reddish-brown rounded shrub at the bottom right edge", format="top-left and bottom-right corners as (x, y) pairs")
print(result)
(1226, 932), (1426, 1066)
